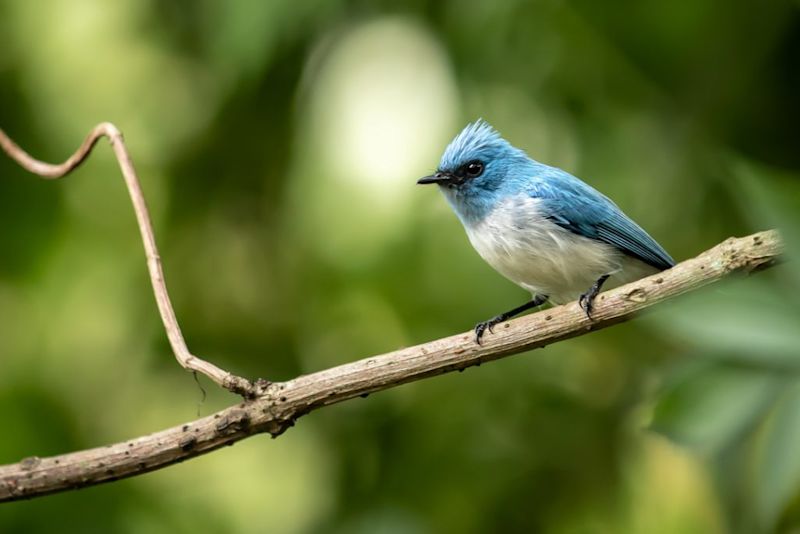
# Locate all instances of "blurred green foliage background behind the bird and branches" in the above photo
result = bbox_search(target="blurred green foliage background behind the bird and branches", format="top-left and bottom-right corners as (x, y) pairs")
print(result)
(0, 0), (800, 533)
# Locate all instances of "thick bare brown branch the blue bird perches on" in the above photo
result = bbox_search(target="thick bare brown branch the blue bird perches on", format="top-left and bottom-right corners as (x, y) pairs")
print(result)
(0, 230), (782, 502)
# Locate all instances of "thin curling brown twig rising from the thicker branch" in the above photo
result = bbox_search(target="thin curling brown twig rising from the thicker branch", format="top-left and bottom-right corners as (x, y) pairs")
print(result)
(0, 122), (256, 397)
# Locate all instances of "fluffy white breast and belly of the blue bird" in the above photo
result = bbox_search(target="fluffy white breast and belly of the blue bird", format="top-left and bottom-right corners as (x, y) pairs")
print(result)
(464, 195), (656, 304)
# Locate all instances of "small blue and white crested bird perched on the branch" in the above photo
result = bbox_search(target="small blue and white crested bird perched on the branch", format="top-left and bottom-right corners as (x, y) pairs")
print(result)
(417, 119), (675, 345)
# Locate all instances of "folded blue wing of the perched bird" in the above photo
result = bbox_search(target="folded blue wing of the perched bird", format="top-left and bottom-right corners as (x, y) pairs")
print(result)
(527, 164), (675, 271)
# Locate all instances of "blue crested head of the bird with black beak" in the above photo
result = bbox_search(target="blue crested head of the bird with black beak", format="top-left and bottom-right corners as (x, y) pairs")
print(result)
(417, 119), (531, 218)
